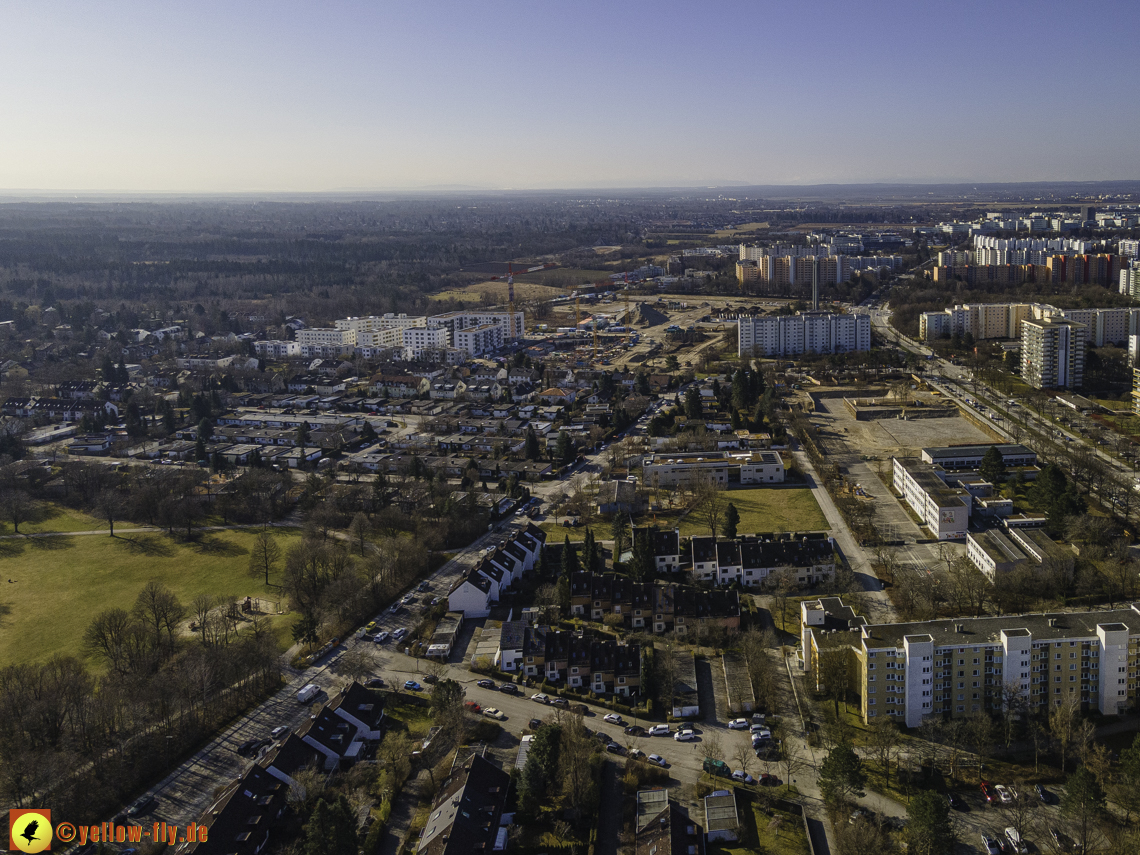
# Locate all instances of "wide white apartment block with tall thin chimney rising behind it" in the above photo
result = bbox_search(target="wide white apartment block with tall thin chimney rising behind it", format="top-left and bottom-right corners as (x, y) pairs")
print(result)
(736, 312), (871, 357)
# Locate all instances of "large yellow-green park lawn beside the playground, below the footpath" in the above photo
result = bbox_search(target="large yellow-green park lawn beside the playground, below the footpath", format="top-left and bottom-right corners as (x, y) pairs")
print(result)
(0, 530), (300, 666)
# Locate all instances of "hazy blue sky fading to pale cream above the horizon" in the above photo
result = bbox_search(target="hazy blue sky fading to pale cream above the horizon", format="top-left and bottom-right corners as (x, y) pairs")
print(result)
(0, 0), (1140, 194)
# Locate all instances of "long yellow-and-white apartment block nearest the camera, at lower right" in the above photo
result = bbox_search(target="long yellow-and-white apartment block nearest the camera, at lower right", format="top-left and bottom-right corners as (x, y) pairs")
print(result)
(801, 597), (1140, 727)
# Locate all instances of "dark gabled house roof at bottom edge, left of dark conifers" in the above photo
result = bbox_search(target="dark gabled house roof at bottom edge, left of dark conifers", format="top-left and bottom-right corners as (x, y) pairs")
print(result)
(417, 755), (511, 855)
